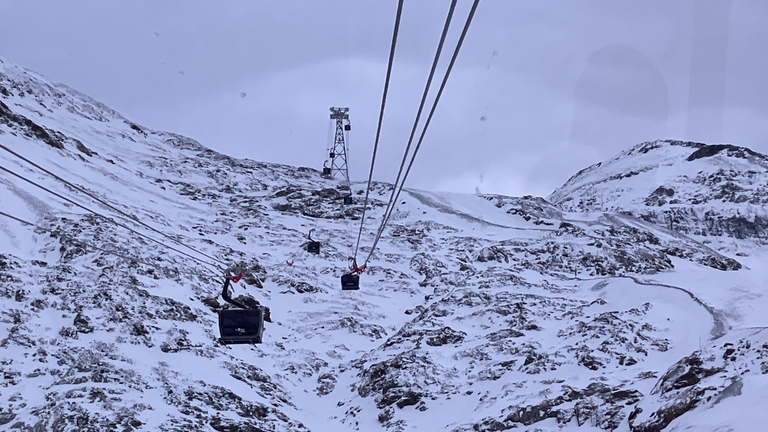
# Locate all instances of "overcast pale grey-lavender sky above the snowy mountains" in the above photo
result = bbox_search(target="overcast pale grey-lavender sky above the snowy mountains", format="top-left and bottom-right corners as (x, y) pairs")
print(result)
(0, 0), (768, 196)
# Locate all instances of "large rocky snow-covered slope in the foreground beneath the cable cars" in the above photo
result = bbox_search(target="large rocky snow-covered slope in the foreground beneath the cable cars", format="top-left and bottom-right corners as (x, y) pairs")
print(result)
(0, 60), (768, 432)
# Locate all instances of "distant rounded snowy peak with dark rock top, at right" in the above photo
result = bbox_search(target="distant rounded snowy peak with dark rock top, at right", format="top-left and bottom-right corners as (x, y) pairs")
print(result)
(549, 140), (768, 243)
